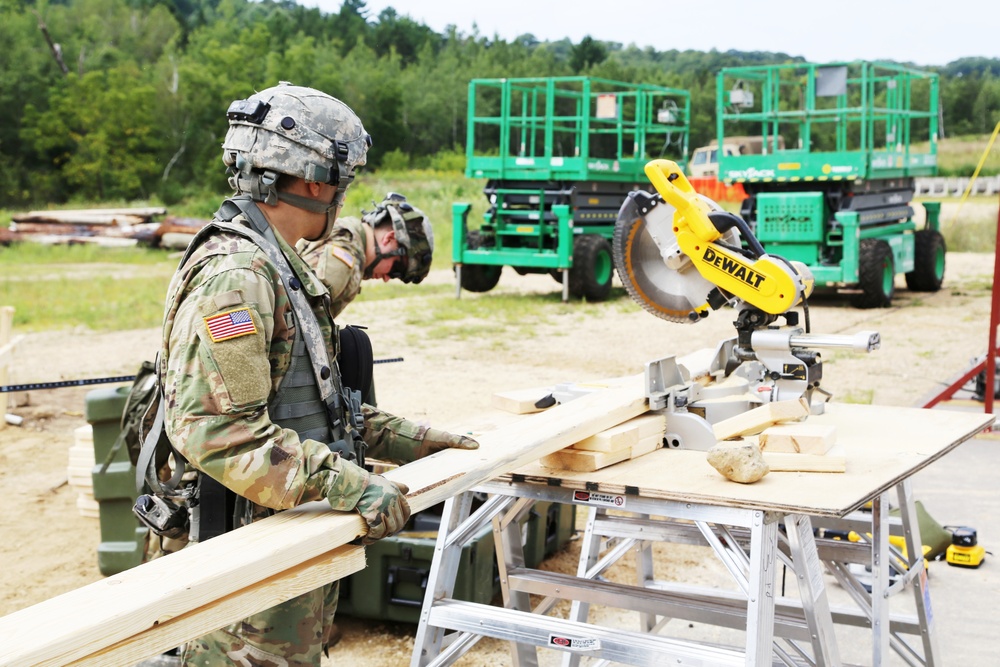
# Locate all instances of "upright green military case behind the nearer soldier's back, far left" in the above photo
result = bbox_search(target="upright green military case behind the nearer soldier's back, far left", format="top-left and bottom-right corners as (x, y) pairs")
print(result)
(85, 386), (146, 575)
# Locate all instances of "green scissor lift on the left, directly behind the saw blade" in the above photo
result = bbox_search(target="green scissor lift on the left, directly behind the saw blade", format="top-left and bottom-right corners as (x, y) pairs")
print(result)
(452, 77), (691, 301)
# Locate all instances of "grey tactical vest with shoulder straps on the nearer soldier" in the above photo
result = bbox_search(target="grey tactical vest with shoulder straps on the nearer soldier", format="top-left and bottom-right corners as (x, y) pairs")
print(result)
(136, 197), (365, 541)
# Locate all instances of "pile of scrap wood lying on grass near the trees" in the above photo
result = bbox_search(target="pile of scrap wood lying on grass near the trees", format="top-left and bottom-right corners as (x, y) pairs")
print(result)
(2, 207), (208, 248)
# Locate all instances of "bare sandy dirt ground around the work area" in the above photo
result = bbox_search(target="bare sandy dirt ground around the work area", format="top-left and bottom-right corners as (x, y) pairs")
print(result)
(0, 247), (994, 666)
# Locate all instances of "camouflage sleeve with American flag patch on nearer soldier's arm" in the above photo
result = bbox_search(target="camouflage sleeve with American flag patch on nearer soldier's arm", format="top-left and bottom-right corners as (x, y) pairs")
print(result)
(164, 253), (362, 509)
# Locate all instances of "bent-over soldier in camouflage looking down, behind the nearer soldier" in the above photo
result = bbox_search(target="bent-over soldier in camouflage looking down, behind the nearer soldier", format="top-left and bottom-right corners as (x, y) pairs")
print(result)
(297, 192), (434, 317)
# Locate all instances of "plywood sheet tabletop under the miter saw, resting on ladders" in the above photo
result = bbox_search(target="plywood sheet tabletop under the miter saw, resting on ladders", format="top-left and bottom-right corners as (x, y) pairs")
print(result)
(502, 404), (994, 517)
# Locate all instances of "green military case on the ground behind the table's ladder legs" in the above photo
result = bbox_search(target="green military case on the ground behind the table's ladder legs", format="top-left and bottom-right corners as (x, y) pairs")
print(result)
(337, 502), (576, 623)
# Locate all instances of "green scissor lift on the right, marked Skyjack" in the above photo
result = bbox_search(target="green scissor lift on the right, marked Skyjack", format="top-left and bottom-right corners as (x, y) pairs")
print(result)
(716, 62), (945, 308)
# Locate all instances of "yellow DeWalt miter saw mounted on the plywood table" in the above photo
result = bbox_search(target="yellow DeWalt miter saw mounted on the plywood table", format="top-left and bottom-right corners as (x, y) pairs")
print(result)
(613, 160), (879, 449)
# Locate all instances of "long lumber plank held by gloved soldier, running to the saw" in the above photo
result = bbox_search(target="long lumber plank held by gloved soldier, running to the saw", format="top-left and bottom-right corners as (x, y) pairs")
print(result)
(0, 376), (648, 666)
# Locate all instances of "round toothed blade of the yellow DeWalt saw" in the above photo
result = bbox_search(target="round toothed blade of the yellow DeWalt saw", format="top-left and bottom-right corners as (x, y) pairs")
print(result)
(612, 192), (715, 323)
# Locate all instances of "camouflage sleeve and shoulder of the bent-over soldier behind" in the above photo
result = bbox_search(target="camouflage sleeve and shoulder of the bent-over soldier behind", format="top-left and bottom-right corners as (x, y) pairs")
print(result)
(297, 218), (365, 318)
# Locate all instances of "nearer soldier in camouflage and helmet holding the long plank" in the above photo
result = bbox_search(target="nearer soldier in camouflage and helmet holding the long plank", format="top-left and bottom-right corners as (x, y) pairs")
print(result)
(159, 84), (478, 667)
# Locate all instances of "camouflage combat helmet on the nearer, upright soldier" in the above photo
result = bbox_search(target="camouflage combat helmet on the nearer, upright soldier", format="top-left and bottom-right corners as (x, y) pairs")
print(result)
(222, 81), (372, 210)
